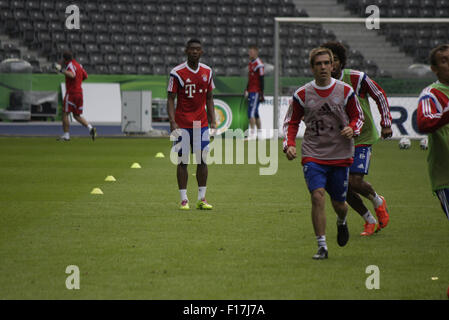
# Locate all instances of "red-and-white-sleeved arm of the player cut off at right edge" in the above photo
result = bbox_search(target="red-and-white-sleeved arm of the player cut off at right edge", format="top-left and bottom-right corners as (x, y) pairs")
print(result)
(416, 95), (449, 133)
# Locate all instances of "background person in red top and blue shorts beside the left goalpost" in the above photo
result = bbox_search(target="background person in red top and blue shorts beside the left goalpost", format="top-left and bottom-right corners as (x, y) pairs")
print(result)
(245, 45), (265, 139)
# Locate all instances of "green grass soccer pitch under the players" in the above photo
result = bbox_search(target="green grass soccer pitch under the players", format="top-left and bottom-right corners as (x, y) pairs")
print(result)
(0, 138), (449, 300)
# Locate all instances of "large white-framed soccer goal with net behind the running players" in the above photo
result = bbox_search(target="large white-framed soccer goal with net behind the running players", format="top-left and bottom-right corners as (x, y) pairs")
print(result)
(273, 17), (449, 139)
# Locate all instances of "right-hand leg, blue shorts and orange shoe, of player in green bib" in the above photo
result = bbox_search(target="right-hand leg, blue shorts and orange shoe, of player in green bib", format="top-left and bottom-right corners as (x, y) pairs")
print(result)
(349, 146), (389, 230)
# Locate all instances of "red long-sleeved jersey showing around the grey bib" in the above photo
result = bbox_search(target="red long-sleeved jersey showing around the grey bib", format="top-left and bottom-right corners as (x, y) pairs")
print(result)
(283, 79), (364, 167)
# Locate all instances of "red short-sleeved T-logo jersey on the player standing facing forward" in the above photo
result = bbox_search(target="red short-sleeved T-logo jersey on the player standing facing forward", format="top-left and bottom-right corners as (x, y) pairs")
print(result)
(167, 62), (215, 128)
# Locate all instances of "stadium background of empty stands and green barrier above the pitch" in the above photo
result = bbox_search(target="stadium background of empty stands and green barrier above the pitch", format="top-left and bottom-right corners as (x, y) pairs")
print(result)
(0, 0), (449, 138)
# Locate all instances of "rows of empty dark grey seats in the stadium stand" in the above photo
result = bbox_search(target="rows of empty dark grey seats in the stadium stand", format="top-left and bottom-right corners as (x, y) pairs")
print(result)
(0, 0), (440, 76)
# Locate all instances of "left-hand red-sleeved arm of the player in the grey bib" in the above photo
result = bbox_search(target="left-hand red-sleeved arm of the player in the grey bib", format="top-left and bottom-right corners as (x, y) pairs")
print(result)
(283, 98), (304, 160)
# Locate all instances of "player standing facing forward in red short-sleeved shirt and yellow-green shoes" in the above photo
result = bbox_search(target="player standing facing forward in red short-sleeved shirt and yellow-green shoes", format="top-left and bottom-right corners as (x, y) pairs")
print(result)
(167, 39), (216, 210)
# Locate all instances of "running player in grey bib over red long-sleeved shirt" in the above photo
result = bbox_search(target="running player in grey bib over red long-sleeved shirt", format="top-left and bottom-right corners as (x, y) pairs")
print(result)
(284, 48), (364, 259)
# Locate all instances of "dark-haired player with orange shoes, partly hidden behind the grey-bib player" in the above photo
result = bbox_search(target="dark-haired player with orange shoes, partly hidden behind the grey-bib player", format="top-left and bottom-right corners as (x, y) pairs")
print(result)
(322, 41), (392, 236)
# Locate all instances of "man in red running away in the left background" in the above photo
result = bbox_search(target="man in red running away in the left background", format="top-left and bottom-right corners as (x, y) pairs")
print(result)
(55, 51), (97, 141)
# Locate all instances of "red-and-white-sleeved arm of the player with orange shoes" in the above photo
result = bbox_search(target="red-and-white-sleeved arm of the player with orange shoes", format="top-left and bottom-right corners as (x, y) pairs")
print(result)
(362, 76), (393, 139)
